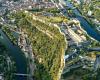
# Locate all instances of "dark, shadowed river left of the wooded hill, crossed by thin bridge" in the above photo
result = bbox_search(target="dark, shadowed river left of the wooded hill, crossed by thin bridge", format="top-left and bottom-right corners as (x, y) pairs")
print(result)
(0, 29), (27, 80)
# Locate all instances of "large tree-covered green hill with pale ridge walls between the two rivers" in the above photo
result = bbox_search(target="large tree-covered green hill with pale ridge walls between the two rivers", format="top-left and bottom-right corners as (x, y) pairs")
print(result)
(14, 12), (66, 80)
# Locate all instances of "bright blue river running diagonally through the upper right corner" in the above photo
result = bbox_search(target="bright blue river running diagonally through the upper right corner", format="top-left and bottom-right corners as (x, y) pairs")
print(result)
(64, 1), (100, 41)
